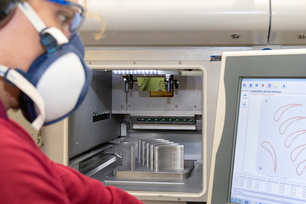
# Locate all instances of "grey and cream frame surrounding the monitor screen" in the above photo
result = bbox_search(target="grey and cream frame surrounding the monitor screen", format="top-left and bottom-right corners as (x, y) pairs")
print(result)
(208, 49), (306, 204)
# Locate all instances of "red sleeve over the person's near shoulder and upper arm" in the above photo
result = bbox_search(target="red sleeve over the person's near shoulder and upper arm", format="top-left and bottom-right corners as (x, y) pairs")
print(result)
(0, 119), (70, 204)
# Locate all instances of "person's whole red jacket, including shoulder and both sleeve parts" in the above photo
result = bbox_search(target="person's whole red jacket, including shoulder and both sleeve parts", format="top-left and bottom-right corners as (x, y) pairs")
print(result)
(0, 118), (142, 204)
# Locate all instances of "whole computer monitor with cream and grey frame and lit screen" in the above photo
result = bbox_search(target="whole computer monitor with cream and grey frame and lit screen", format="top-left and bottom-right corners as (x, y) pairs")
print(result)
(208, 49), (306, 204)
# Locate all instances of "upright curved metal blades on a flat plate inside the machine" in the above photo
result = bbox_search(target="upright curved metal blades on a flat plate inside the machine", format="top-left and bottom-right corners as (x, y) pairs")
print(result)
(113, 139), (188, 179)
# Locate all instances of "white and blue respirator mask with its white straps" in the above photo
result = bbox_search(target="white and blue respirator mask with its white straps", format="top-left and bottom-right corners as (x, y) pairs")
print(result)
(0, 2), (92, 130)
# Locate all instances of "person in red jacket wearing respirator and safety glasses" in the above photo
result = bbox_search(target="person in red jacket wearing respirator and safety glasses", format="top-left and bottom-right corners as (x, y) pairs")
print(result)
(0, 0), (142, 204)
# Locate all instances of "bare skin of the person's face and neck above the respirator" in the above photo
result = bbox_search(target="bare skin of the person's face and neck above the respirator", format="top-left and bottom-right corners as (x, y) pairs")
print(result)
(0, 0), (82, 76)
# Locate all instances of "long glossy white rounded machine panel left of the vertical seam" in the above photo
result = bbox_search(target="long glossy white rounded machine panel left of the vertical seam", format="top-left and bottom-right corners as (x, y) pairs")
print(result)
(81, 0), (269, 46)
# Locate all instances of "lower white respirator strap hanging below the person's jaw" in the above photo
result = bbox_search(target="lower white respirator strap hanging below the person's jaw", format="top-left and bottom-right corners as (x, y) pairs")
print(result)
(0, 65), (45, 131)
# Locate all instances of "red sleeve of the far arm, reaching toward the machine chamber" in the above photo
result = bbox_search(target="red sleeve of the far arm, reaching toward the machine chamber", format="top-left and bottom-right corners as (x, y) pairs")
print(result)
(54, 163), (142, 204)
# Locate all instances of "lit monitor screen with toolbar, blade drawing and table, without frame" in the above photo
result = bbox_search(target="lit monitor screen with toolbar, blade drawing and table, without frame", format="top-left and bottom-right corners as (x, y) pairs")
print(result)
(228, 78), (306, 204)
